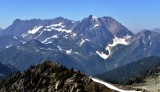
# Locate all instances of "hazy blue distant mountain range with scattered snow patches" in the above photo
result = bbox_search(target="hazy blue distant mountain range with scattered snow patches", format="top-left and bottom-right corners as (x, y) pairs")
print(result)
(0, 15), (160, 75)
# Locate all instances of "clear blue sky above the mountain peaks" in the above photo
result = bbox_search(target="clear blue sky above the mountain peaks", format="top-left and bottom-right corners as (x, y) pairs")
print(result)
(0, 0), (160, 32)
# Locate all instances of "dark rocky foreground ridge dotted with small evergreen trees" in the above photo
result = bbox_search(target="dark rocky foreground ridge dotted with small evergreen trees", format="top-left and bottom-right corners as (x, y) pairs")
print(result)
(0, 62), (115, 92)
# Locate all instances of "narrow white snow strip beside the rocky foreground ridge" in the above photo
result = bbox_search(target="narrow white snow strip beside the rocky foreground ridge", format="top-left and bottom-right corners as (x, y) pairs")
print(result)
(90, 77), (142, 92)
